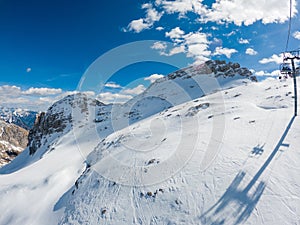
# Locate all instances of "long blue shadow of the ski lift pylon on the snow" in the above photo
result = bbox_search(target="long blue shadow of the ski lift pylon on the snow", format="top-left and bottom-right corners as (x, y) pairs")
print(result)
(200, 117), (295, 225)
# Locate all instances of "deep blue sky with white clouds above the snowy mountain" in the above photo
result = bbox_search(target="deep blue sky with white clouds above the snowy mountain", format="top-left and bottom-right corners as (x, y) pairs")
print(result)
(0, 0), (300, 110)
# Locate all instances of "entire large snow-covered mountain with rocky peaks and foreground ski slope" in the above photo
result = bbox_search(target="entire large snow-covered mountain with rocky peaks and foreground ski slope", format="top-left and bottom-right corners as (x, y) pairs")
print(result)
(0, 61), (300, 224)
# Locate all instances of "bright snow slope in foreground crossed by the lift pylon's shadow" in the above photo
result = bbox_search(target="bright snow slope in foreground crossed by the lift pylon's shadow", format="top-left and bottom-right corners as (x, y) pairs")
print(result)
(54, 80), (300, 224)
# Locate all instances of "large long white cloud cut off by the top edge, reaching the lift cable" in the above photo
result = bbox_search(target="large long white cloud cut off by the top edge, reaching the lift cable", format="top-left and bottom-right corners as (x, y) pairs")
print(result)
(143, 0), (297, 26)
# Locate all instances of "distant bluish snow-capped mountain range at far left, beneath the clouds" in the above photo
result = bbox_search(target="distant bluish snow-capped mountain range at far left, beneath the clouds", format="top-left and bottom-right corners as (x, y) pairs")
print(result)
(0, 106), (37, 130)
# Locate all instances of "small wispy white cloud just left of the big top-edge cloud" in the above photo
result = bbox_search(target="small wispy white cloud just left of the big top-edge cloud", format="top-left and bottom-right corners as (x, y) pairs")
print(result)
(124, 3), (163, 33)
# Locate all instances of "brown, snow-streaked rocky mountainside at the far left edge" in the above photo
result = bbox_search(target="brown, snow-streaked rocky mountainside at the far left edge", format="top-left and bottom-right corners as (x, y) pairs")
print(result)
(0, 120), (28, 167)
